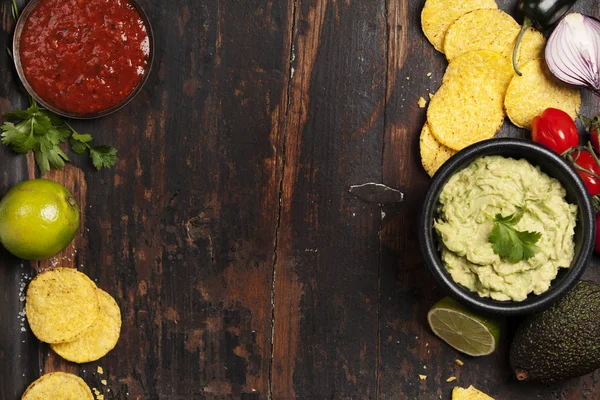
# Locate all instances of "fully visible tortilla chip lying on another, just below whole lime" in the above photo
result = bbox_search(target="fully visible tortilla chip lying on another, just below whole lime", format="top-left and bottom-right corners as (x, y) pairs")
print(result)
(25, 268), (100, 343)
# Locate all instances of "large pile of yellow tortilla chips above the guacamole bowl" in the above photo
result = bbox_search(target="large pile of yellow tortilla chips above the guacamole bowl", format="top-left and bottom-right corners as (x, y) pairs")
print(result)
(420, 0), (581, 175)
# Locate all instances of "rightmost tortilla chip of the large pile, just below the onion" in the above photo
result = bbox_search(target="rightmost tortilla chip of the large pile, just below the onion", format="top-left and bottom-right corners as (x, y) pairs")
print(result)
(504, 58), (581, 128)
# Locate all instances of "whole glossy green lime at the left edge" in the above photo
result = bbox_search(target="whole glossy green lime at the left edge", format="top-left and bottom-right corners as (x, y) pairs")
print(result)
(0, 179), (79, 260)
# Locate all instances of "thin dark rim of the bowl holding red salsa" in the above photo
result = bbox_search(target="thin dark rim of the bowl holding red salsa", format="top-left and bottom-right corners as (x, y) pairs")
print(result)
(12, 0), (154, 120)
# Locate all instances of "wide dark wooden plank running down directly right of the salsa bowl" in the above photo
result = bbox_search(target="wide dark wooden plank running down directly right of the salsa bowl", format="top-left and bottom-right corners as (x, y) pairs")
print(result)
(81, 1), (291, 399)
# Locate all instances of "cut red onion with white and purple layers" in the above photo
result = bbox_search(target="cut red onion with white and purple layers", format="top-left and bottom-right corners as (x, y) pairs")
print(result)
(546, 13), (600, 96)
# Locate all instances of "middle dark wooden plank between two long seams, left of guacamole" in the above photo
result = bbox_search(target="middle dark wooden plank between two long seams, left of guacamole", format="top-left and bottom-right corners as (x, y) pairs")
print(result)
(272, 1), (385, 399)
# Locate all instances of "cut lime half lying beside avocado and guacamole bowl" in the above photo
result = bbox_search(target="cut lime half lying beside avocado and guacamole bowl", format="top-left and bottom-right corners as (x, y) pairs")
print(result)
(427, 297), (500, 356)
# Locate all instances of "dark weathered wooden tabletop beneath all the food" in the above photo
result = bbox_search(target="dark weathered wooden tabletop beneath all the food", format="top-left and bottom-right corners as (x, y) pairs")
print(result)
(0, 0), (600, 400)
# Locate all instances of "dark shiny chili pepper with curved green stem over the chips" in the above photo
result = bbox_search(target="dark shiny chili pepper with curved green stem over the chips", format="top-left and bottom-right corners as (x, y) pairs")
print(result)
(513, 0), (577, 76)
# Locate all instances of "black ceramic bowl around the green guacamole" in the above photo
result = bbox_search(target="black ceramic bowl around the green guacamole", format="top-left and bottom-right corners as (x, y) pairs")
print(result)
(419, 139), (595, 315)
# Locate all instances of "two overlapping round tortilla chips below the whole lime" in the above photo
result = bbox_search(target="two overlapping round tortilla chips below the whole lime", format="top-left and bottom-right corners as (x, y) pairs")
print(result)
(25, 268), (121, 363)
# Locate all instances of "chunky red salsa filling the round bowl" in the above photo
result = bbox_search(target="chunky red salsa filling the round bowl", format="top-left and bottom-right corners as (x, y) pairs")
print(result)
(19, 0), (150, 114)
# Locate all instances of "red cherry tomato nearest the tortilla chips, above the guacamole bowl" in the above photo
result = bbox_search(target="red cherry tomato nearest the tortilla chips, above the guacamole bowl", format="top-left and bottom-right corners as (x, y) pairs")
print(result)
(531, 108), (579, 154)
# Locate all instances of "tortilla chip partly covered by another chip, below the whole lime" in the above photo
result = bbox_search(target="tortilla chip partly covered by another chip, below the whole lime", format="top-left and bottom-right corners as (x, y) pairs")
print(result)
(51, 289), (121, 364)
